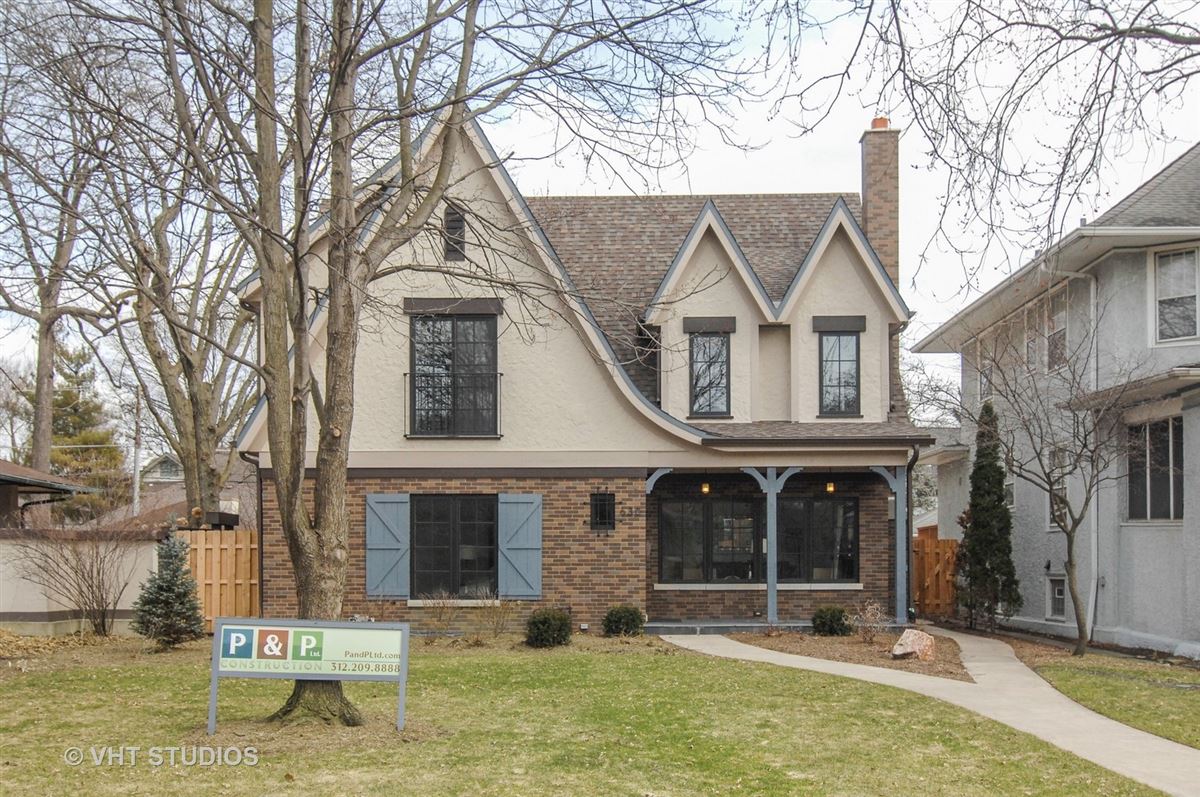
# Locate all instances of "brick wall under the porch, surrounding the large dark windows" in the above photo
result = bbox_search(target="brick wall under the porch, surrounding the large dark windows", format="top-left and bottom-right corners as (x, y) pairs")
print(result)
(646, 473), (895, 622)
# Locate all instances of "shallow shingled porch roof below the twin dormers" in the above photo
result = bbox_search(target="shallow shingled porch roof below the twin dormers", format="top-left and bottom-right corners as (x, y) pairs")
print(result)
(692, 420), (934, 448)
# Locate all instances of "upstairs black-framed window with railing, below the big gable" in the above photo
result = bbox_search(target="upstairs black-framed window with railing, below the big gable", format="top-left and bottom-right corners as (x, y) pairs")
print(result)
(410, 316), (499, 437)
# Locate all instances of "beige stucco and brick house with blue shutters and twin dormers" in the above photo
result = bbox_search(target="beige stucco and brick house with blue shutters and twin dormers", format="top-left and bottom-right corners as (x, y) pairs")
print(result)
(239, 120), (931, 625)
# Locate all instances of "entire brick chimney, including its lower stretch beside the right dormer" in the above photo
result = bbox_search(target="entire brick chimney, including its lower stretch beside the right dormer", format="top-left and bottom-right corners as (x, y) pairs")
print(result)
(858, 116), (908, 420)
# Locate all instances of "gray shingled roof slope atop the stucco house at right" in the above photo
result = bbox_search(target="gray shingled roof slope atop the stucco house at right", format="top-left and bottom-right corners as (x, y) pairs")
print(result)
(1092, 144), (1200, 227)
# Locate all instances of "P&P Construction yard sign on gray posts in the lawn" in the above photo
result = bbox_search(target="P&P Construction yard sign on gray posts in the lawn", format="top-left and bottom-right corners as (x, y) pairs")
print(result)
(209, 617), (408, 735)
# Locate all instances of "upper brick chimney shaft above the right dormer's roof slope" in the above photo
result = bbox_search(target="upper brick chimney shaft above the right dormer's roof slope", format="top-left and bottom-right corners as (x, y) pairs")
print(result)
(858, 116), (900, 287)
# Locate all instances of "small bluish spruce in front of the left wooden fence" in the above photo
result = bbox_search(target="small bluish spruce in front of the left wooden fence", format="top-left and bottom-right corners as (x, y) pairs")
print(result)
(131, 534), (204, 651)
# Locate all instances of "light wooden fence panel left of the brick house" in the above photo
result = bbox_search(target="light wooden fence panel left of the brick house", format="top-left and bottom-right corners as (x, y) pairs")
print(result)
(178, 529), (259, 634)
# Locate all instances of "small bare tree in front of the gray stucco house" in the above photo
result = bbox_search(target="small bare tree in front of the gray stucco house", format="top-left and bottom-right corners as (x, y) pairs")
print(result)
(916, 298), (1148, 655)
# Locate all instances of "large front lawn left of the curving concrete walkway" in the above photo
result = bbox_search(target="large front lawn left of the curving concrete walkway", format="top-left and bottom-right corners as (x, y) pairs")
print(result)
(0, 639), (1154, 796)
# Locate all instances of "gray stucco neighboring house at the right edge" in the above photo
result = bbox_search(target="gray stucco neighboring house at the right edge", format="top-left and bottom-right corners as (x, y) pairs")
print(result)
(916, 145), (1200, 657)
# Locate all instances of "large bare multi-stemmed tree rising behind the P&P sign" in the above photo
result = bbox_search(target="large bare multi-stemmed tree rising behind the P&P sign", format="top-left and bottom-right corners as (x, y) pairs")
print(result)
(54, 0), (743, 724)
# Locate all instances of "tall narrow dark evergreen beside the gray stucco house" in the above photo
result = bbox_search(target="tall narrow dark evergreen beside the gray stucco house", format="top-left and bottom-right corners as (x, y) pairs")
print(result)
(958, 402), (1021, 628)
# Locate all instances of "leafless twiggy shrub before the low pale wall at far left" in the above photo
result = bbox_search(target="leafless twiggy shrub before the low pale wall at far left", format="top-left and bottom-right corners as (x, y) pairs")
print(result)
(13, 529), (144, 636)
